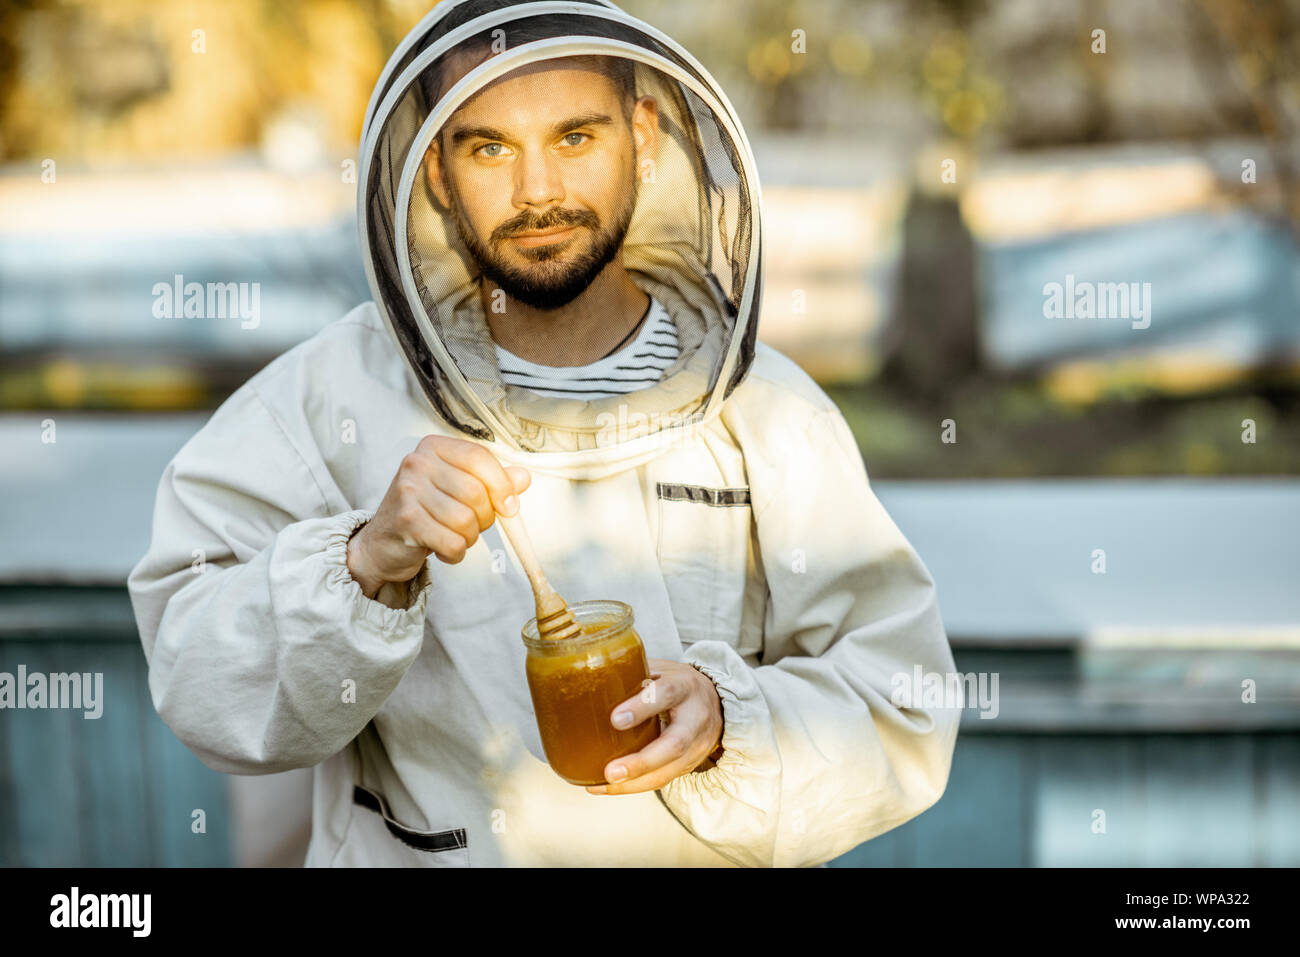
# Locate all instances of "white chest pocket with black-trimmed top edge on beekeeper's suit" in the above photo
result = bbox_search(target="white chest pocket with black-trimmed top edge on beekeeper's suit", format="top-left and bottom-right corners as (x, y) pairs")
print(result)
(655, 482), (762, 654)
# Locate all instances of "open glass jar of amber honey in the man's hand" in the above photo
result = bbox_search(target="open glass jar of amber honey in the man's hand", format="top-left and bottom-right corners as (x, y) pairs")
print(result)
(523, 601), (659, 785)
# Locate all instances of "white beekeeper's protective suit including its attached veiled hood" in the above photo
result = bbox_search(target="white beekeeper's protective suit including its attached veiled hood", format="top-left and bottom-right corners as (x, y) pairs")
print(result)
(129, 0), (961, 866)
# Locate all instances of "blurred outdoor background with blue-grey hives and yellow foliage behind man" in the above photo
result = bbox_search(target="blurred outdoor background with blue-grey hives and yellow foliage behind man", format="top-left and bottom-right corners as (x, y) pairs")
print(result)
(0, 0), (1300, 866)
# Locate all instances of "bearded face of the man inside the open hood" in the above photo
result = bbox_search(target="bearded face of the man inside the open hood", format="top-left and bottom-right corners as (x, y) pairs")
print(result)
(425, 61), (658, 309)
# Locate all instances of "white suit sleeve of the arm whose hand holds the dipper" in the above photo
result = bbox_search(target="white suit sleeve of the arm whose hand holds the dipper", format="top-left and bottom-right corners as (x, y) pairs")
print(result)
(127, 386), (432, 774)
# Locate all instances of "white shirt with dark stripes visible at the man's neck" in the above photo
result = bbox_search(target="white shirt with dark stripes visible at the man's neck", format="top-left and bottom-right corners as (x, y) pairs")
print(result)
(497, 296), (680, 399)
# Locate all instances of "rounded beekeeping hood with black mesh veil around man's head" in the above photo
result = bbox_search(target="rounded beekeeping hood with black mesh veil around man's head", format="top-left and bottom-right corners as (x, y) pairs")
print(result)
(359, 0), (761, 477)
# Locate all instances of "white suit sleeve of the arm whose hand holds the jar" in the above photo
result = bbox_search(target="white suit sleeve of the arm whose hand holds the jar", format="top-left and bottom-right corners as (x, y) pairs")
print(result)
(659, 407), (961, 867)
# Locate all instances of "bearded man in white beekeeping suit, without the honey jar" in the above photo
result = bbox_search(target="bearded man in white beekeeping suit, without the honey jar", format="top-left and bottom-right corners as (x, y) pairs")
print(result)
(130, 0), (958, 866)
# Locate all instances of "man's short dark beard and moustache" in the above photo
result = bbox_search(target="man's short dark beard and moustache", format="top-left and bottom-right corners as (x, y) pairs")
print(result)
(449, 167), (640, 312)
